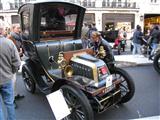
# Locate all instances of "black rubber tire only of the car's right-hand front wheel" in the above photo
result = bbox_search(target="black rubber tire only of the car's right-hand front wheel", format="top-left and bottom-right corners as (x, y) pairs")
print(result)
(111, 67), (135, 104)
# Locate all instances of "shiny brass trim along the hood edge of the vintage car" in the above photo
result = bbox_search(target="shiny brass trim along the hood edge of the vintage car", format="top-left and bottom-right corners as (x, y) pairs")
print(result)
(71, 56), (98, 82)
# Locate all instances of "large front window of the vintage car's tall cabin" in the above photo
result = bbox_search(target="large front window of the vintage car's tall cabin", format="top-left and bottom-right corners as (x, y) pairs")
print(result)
(40, 5), (78, 39)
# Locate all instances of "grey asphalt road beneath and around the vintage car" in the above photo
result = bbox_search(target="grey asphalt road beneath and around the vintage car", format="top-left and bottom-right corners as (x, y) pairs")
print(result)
(12, 65), (160, 120)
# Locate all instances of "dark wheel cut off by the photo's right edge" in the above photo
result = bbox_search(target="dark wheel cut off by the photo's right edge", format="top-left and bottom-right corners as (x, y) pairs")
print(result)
(153, 52), (160, 74)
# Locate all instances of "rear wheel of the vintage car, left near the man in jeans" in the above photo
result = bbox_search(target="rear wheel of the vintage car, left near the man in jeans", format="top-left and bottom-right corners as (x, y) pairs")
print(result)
(22, 68), (36, 94)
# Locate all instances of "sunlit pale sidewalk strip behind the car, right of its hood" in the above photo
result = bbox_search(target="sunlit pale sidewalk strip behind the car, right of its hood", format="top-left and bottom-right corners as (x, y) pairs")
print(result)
(115, 55), (153, 67)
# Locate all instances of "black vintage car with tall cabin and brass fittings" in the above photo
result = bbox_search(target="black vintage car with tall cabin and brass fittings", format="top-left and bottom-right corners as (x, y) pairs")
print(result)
(19, 0), (135, 120)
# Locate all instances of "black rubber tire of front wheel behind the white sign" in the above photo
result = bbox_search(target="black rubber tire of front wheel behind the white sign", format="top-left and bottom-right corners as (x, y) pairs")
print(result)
(61, 85), (94, 120)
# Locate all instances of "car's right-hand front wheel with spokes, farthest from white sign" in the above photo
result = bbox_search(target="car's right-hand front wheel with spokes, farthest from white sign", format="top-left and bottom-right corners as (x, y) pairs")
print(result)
(112, 68), (135, 103)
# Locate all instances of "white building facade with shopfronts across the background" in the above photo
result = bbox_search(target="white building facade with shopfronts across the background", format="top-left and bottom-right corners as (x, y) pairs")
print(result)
(0, 0), (160, 31)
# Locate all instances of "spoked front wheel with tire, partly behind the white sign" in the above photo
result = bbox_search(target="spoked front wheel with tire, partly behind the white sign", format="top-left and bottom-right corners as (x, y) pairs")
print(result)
(61, 85), (94, 120)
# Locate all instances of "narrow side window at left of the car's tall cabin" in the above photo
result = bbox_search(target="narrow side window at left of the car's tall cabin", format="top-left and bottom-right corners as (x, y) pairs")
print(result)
(22, 11), (30, 40)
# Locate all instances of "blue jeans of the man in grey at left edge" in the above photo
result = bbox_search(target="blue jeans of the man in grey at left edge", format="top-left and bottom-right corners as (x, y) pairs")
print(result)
(0, 81), (16, 120)
